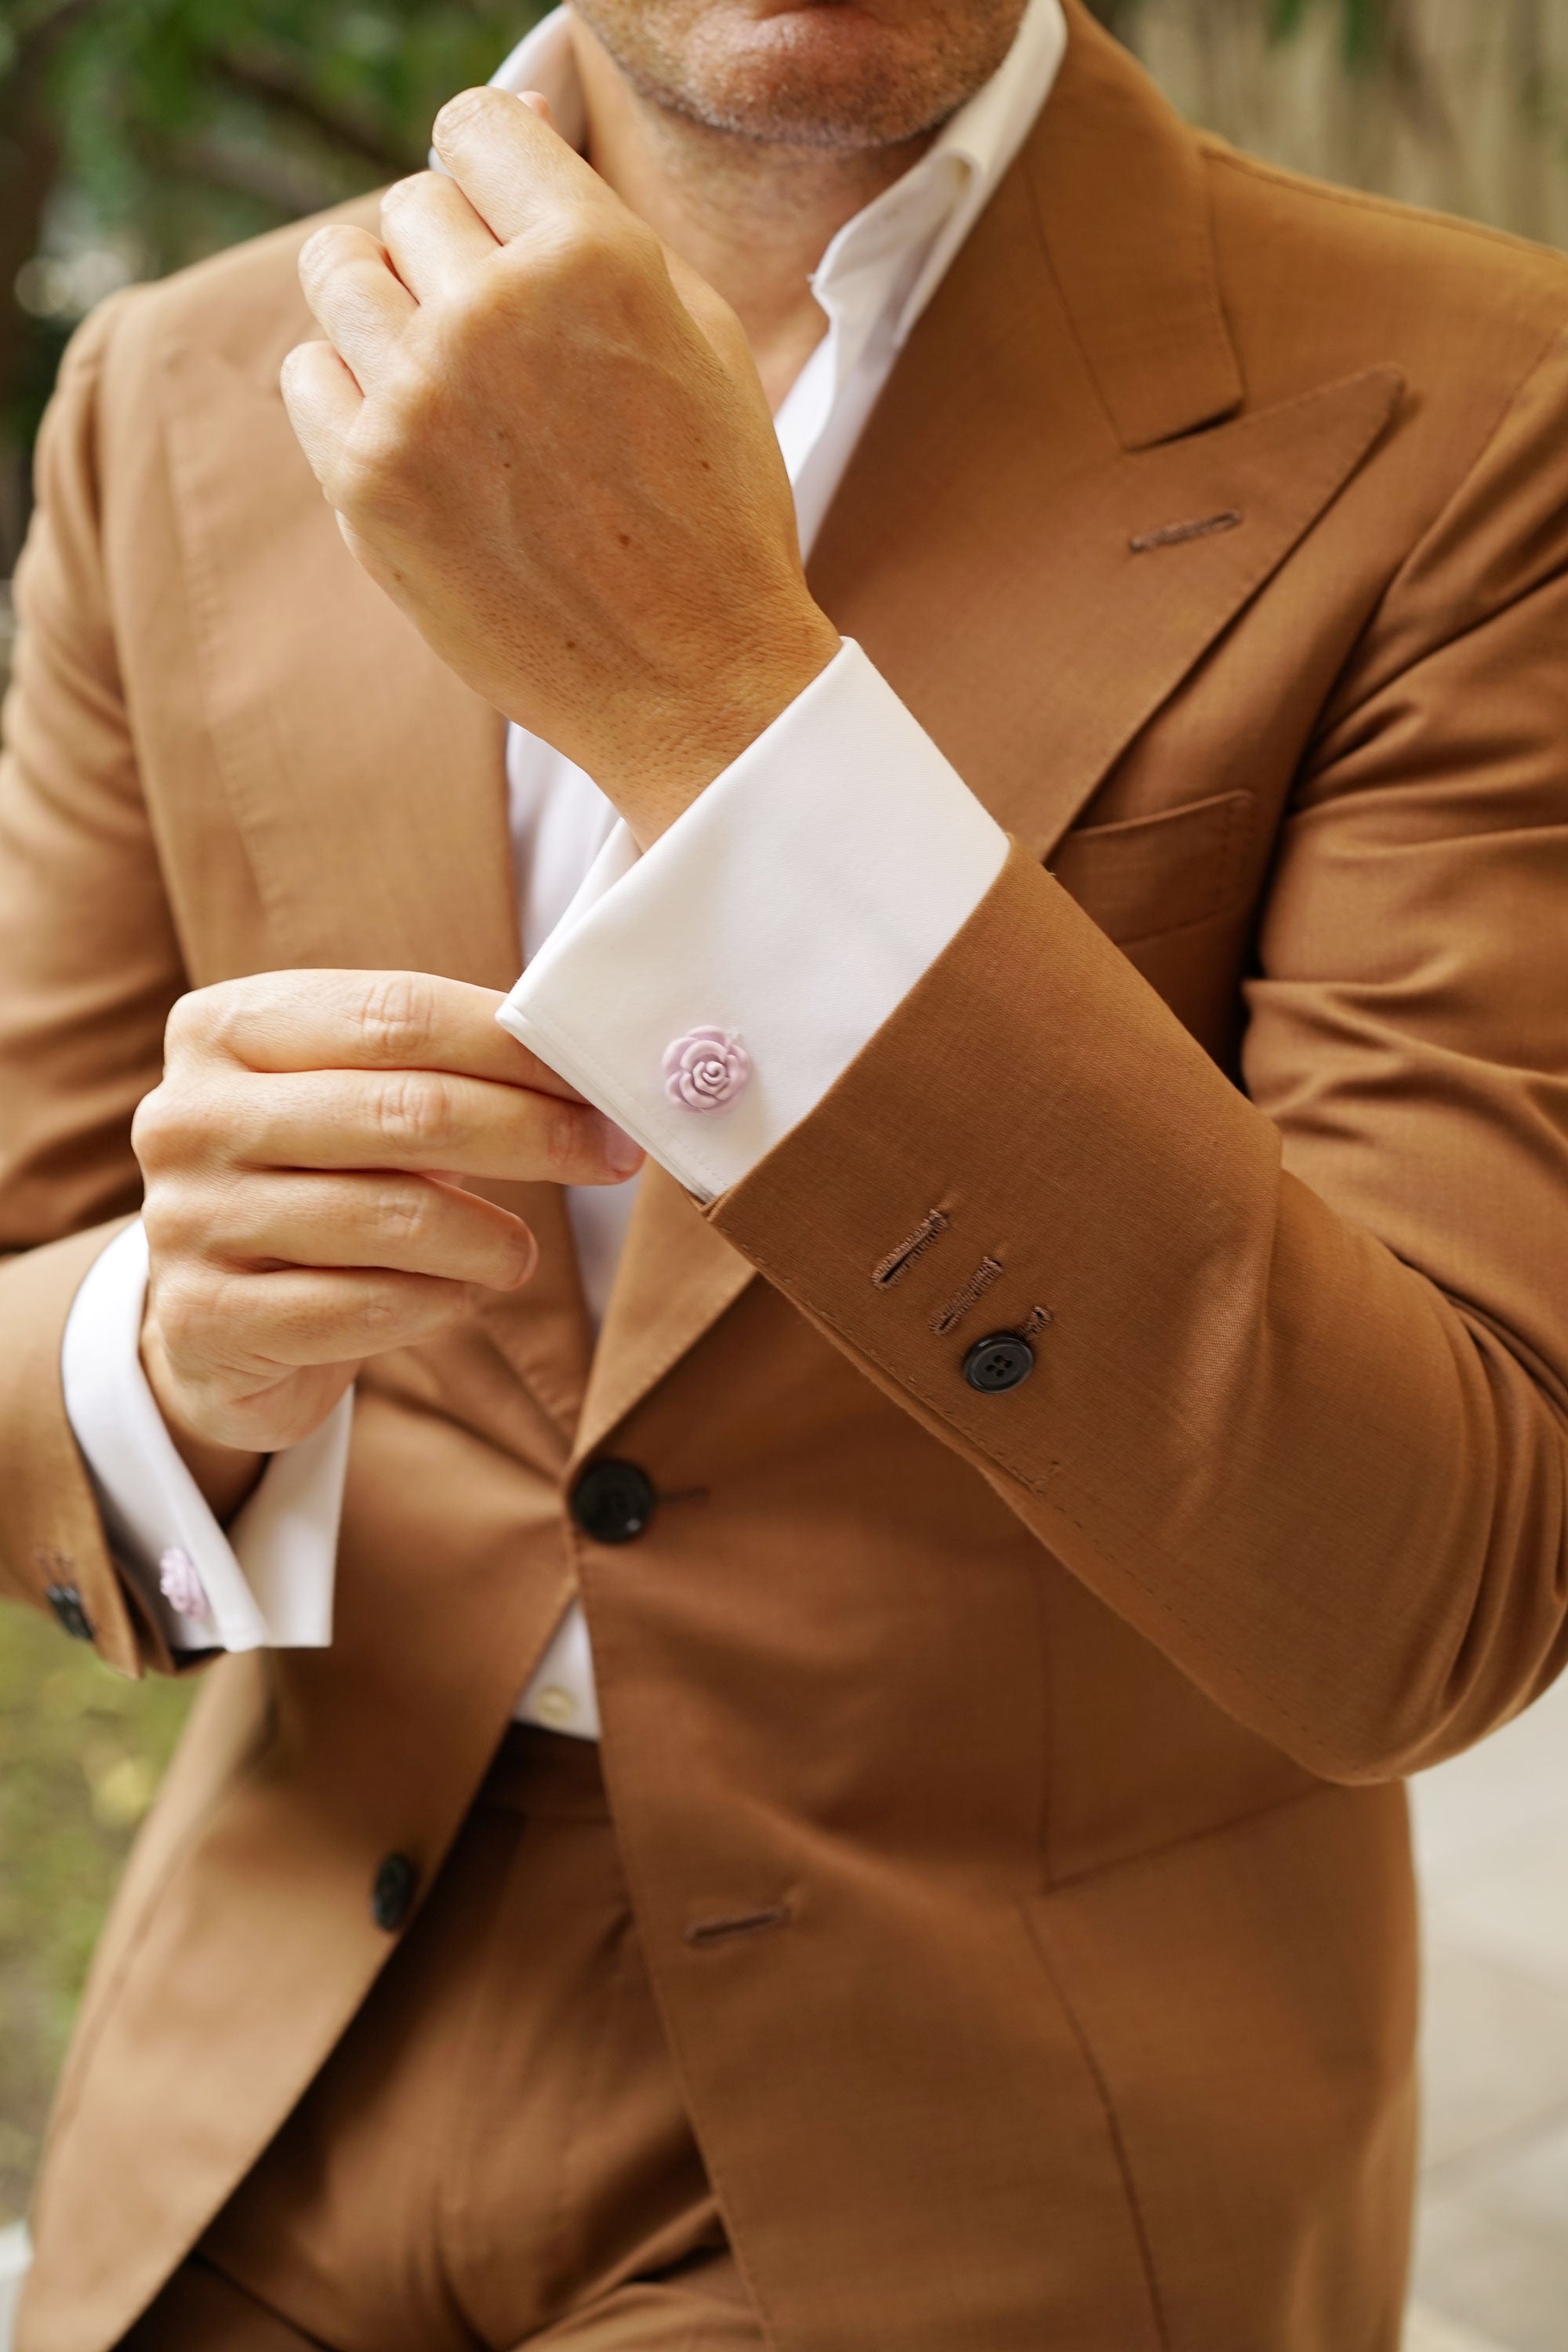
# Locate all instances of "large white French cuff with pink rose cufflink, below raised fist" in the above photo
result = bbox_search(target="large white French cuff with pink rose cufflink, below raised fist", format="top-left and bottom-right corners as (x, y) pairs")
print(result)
(496, 640), (1006, 1200)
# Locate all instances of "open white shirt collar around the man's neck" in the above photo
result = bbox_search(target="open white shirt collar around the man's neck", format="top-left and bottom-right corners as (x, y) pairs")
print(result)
(494, 0), (1067, 346)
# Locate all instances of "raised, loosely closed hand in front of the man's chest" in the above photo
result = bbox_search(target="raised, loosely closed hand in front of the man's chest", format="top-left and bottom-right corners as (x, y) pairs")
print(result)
(285, 89), (839, 847)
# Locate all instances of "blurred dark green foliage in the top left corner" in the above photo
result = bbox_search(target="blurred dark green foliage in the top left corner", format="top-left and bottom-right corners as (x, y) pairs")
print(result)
(0, 0), (543, 534)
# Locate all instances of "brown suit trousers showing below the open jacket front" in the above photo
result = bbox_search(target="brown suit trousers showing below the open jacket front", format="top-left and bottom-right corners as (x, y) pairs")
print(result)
(122, 1724), (764, 2352)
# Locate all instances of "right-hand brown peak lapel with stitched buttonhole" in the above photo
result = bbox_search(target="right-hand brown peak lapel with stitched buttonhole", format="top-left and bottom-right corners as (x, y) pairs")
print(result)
(579, 0), (1399, 1454)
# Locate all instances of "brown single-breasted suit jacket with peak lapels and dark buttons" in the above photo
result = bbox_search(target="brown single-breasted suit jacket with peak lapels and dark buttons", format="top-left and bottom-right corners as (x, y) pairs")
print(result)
(0, 7), (1568, 2352)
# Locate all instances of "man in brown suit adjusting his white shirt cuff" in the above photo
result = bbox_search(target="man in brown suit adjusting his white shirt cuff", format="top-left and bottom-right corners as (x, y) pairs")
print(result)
(0, 0), (1568, 2352)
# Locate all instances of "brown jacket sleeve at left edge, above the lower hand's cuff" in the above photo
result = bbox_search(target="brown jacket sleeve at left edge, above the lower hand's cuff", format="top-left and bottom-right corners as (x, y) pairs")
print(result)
(0, 303), (186, 1672)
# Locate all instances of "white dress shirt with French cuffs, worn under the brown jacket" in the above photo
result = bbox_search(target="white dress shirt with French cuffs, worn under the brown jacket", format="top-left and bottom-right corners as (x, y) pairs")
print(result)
(61, 0), (1067, 1738)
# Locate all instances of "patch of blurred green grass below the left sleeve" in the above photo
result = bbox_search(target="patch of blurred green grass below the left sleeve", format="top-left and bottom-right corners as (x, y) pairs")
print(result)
(0, 1604), (191, 2227)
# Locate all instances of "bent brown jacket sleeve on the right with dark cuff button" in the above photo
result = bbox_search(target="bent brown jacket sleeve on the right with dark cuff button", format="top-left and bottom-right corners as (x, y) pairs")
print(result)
(710, 327), (1568, 1780)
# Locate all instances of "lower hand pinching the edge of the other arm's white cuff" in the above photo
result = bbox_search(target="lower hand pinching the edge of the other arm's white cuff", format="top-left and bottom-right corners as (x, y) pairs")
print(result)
(132, 971), (642, 1515)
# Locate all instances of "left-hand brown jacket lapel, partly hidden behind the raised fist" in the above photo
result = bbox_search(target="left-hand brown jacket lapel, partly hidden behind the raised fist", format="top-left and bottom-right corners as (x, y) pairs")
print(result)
(167, 332), (590, 1439)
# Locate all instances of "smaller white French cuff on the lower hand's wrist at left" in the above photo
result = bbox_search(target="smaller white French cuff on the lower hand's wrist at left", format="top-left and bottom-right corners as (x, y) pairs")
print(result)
(61, 1223), (353, 1649)
